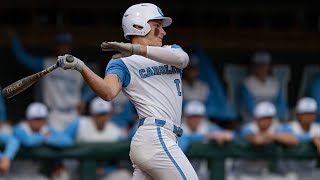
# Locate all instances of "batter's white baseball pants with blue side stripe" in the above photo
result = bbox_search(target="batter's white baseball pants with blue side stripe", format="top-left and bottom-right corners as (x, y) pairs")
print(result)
(130, 121), (198, 180)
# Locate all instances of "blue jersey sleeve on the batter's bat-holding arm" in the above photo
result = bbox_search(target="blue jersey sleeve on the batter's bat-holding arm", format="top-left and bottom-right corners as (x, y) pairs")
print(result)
(105, 59), (131, 87)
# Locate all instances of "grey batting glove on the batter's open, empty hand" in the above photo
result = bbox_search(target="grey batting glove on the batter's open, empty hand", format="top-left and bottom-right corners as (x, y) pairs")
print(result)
(100, 42), (141, 59)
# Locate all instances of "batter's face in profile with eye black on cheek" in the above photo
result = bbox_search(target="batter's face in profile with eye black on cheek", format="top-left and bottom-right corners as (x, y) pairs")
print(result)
(144, 19), (166, 47)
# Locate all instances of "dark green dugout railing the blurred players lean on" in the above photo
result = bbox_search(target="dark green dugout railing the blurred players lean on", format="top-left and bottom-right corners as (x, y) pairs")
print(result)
(11, 142), (319, 180)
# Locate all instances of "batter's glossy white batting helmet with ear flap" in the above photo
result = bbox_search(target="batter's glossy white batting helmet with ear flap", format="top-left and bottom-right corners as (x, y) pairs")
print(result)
(122, 3), (172, 40)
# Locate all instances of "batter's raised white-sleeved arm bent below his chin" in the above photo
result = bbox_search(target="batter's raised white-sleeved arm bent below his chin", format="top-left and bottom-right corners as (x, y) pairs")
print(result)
(141, 46), (189, 69)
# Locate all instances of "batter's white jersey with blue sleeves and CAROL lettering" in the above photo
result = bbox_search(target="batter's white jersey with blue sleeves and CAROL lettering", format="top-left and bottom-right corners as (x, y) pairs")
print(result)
(106, 45), (182, 125)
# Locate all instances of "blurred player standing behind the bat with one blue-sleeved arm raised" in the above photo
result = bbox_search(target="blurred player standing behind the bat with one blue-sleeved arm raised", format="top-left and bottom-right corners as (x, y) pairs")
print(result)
(11, 32), (94, 130)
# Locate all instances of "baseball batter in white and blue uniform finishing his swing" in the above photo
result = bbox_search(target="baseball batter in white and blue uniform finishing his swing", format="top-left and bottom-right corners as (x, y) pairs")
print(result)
(57, 3), (198, 180)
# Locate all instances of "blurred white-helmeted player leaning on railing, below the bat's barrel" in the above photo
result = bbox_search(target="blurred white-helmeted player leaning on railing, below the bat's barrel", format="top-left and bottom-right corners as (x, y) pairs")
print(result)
(11, 102), (73, 180)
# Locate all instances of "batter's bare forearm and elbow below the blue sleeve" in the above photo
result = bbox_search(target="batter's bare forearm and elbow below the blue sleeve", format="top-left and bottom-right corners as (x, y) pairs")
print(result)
(81, 66), (121, 101)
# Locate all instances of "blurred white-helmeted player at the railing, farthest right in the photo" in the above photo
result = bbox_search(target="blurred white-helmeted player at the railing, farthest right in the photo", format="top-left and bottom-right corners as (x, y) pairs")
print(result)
(279, 97), (320, 180)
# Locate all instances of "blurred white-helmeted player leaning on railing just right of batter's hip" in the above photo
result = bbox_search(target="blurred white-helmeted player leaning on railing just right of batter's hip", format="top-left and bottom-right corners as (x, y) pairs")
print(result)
(179, 101), (234, 180)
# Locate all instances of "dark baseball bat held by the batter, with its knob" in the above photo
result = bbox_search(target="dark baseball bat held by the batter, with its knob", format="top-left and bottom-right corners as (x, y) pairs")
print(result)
(2, 55), (74, 99)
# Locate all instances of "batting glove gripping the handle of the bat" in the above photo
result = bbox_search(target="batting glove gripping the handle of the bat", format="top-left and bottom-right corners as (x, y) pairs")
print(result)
(57, 54), (84, 72)
